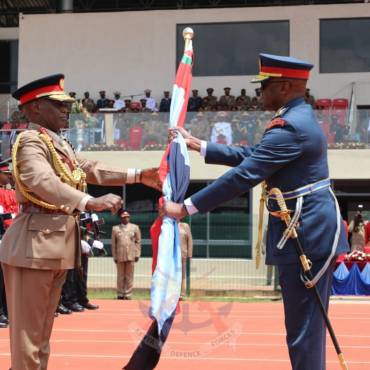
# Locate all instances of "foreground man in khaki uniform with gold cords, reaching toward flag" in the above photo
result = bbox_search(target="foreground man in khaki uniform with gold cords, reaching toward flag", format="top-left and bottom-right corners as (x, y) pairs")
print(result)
(0, 74), (158, 370)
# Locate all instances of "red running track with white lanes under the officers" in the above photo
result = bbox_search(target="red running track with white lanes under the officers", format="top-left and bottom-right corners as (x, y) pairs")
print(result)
(0, 300), (370, 370)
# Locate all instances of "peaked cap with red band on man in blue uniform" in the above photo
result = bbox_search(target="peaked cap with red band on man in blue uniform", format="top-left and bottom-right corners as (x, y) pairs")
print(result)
(251, 54), (313, 82)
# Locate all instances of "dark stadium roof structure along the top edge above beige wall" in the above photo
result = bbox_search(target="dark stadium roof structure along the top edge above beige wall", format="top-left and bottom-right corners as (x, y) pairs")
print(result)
(0, 0), (369, 27)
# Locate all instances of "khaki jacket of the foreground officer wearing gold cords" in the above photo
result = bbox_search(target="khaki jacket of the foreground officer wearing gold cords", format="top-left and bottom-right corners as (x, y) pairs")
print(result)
(0, 124), (127, 270)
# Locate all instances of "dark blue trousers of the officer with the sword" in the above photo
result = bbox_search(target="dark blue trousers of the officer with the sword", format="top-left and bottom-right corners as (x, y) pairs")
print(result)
(278, 258), (335, 370)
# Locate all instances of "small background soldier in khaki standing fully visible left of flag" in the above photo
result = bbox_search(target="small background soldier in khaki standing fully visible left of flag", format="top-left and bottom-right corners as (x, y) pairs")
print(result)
(112, 210), (141, 299)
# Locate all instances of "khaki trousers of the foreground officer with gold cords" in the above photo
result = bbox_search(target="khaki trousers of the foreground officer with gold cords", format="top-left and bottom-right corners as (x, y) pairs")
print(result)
(2, 264), (67, 370)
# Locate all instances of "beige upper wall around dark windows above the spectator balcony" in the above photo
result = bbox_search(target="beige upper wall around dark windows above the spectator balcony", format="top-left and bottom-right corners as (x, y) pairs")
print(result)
(19, 4), (370, 104)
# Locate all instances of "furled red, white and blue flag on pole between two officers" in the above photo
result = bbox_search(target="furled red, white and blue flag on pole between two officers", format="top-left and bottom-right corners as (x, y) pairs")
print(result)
(124, 28), (193, 370)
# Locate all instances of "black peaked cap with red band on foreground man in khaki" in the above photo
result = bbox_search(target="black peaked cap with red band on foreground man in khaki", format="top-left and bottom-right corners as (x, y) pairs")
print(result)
(12, 74), (75, 105)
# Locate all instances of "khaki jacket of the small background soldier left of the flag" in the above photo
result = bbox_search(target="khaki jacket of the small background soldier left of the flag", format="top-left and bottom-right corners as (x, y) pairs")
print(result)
(112, 222), (141, 262)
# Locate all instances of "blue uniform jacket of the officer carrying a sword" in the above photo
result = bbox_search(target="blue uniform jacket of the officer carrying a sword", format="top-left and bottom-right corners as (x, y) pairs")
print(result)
(191, 98), (348, 264)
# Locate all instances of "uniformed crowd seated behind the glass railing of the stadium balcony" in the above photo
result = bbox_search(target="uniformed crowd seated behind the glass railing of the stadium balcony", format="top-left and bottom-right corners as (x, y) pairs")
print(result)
(2, 87), (367, 151)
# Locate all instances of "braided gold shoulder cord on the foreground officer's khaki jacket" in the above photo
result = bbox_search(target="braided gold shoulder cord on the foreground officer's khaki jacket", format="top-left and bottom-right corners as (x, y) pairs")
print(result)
(12, 133), (86, 210)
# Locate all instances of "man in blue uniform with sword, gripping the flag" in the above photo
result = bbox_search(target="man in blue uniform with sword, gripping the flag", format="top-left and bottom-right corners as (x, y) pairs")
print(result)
(162, 54), (348, 370)
